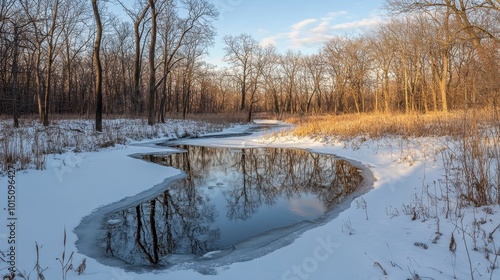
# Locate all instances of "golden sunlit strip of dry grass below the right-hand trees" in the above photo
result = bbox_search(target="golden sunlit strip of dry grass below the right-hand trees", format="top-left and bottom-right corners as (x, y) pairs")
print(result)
(286, 110), (496, 140)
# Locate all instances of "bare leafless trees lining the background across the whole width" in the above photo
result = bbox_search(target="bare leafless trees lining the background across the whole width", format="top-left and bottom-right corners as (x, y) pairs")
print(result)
(0, 0), (500, 130)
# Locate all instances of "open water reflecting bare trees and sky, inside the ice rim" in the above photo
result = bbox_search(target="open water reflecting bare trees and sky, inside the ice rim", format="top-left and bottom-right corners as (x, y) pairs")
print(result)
(104, 146), (363, 265)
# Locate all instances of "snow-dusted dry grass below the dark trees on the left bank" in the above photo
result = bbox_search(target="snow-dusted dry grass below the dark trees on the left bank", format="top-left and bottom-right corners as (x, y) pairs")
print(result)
(0, 118), (232, 176)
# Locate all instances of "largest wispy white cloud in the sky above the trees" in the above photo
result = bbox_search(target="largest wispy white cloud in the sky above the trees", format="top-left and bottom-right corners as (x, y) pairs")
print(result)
(260, 11), (382, 49)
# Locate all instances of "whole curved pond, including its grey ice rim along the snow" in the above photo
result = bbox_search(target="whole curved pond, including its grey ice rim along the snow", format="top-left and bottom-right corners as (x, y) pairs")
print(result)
(75, 123), (371, 273)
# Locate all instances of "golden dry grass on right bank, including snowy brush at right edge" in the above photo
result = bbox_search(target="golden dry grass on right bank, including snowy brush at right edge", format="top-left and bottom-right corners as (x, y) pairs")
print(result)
(287, 109), (500, 208)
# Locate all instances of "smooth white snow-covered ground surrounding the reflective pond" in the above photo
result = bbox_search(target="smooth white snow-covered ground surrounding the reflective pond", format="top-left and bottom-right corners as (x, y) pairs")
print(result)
(0, 120), (500, 280)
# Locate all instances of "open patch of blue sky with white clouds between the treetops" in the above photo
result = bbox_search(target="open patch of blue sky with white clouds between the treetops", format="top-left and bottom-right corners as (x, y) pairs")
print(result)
(209, 0), (385, 65)
